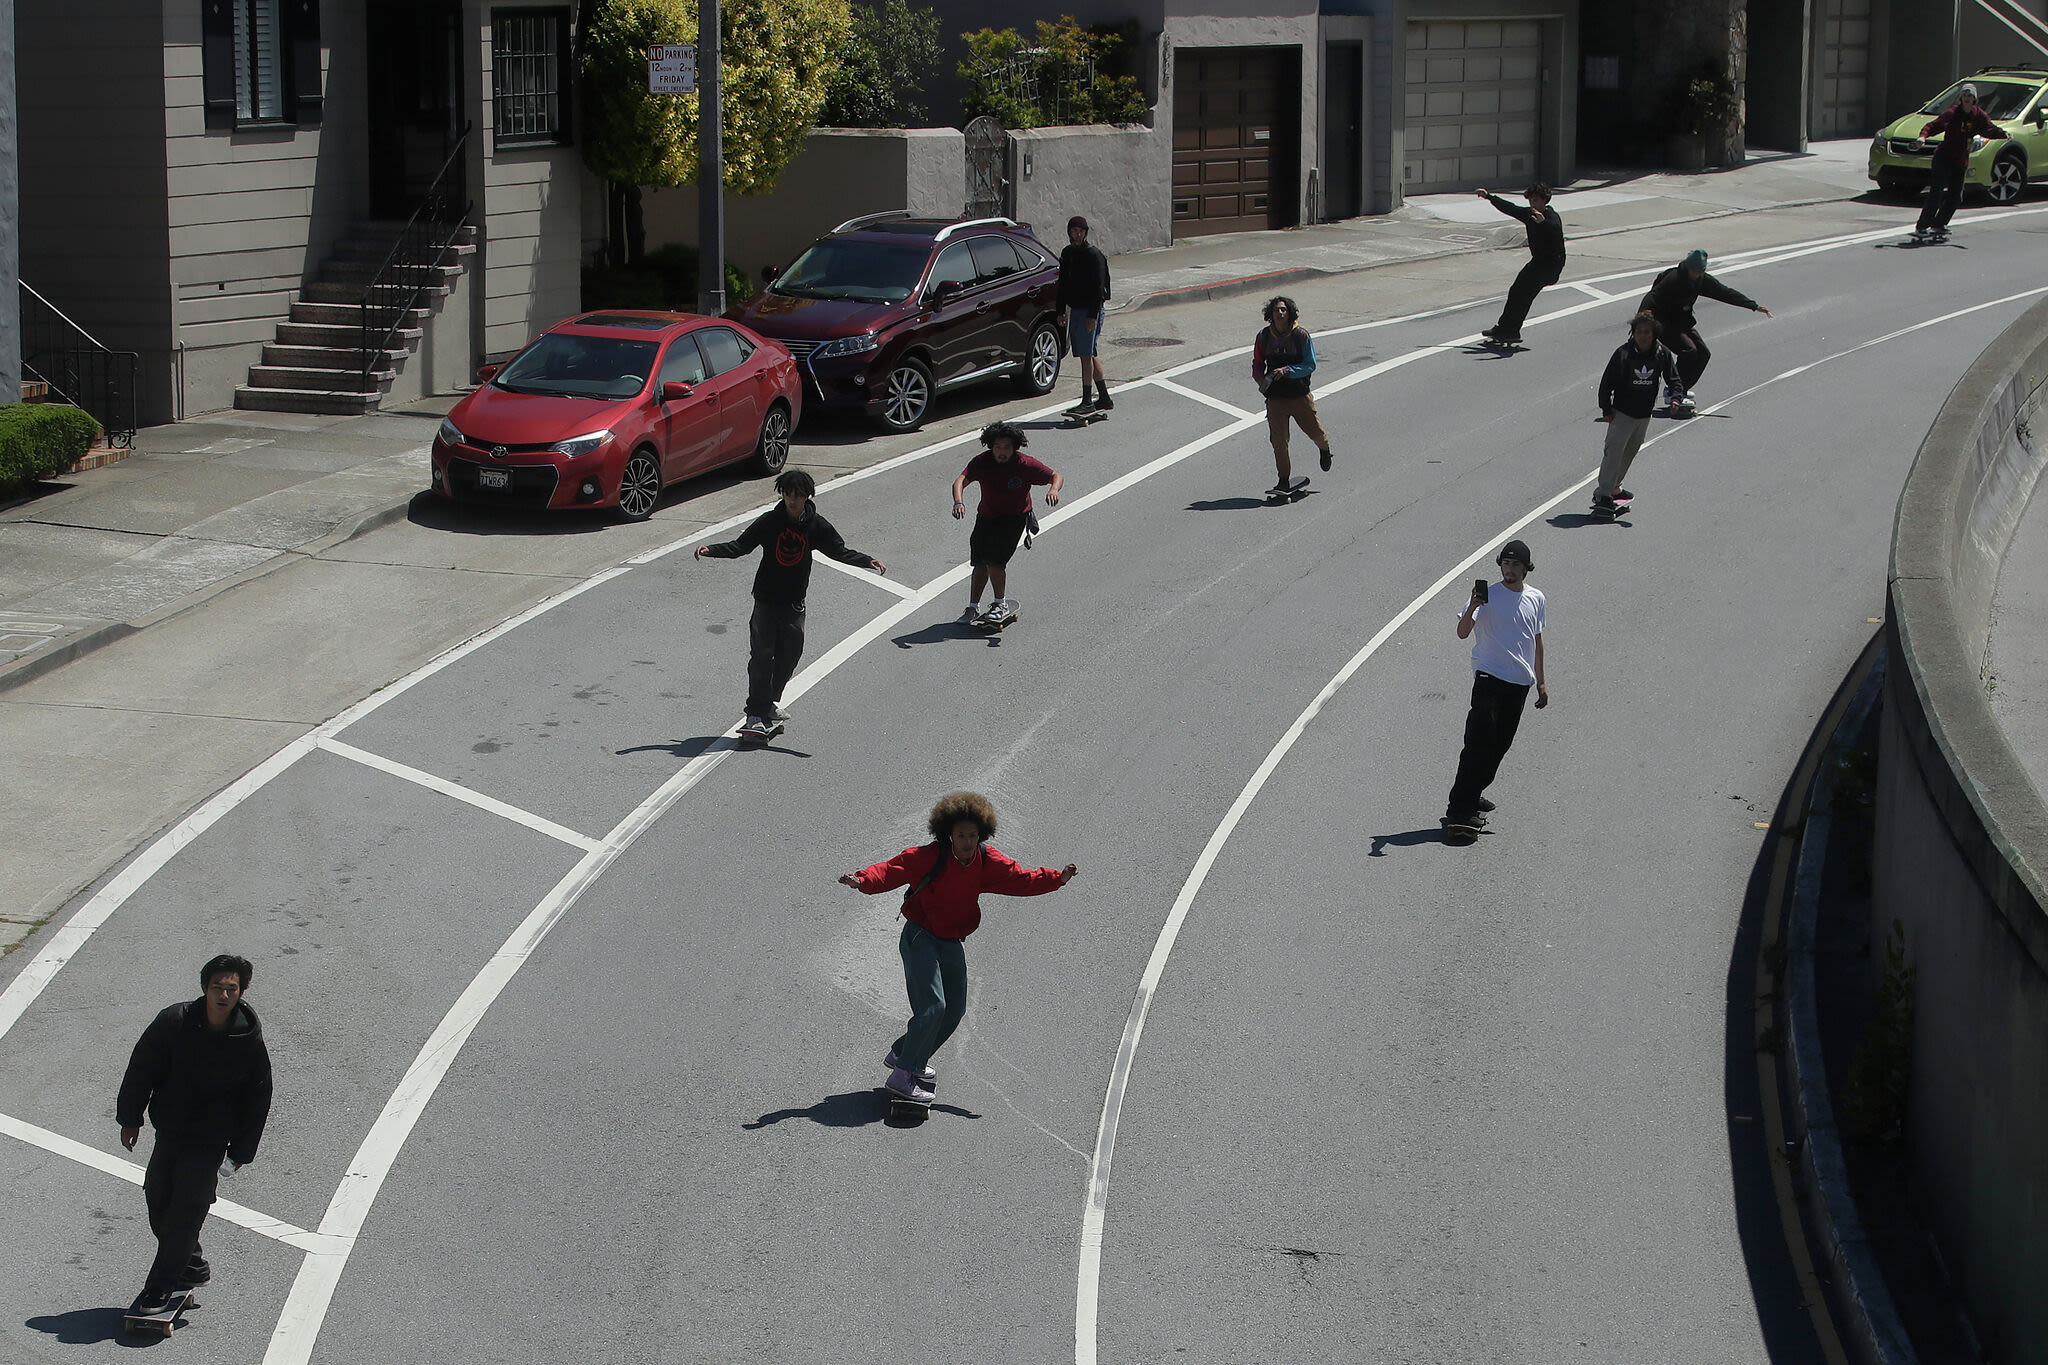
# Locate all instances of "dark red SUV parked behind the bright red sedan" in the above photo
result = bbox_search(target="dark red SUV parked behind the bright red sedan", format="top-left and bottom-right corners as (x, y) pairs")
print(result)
(733, 211), (1067, 432)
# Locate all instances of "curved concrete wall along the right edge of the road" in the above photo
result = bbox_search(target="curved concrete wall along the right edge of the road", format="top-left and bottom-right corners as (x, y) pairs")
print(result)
(1872, 294), (2048, 1365)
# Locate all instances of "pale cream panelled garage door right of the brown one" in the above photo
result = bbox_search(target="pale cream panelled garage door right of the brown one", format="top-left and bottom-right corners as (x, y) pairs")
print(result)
(1401, 20), (1542, 194)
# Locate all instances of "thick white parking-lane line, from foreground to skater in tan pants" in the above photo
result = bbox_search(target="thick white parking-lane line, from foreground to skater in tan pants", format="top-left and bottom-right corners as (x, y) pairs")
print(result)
(251, 405), (1260, 1365)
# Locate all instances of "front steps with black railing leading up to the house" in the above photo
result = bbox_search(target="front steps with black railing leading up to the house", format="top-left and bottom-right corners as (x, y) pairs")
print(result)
(236, 223), (477, 413)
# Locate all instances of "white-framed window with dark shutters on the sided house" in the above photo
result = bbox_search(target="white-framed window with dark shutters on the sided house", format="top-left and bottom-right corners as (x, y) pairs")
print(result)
(199, 0), (322, 129)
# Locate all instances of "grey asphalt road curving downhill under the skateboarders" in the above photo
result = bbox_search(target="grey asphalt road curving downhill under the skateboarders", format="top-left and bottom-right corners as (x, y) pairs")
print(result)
(0, 209), (2048, 1363)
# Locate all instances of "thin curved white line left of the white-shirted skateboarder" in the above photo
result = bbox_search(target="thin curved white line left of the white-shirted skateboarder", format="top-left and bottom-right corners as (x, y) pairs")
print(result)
(1073, 284), (2048, 1365)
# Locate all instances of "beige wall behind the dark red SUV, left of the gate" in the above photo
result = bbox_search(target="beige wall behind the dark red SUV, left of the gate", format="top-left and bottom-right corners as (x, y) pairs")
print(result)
(643, 129), (967, 284)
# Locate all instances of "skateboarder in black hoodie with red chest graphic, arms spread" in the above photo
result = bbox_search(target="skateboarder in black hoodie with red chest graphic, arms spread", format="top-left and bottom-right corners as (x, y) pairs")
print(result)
(696, 469), (889, 743)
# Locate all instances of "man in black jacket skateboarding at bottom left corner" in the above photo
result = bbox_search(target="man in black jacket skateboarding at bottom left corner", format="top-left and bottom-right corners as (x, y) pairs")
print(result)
(115, 954), (270, 1318)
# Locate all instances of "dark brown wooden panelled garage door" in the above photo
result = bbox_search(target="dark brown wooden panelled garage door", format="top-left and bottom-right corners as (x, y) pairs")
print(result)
(1174, 47), (1300, 237)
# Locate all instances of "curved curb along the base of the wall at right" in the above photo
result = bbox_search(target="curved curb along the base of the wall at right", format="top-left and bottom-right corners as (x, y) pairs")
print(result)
(1780, 634), (1919, 1365)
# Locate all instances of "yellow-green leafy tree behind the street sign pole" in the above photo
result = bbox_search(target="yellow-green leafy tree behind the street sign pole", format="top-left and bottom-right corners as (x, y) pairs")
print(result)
(580, 0), (852, 262)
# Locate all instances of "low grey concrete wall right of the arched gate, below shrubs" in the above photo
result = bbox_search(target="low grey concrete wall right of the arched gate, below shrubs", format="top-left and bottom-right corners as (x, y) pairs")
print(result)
(1010, 125), (1174, 256)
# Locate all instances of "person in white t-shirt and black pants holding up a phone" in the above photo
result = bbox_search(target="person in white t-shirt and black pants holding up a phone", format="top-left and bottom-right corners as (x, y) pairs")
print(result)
(1444, 540), (1550, 829)
